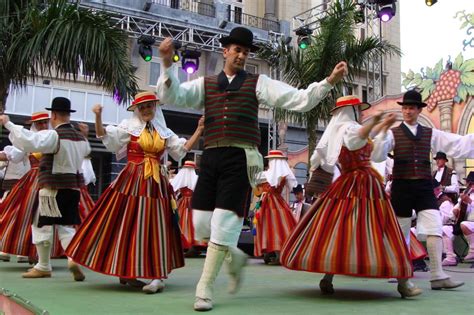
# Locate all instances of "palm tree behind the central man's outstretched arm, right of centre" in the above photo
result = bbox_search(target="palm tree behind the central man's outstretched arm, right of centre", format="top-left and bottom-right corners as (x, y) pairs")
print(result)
(259, 0), (400, 158)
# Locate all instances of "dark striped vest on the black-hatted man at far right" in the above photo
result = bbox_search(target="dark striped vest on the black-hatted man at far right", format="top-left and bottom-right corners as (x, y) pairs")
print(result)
(392, 123), (432, 180)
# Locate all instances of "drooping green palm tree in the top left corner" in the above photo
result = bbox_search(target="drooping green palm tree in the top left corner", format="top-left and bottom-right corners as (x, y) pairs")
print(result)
(0, 0), (137, 112)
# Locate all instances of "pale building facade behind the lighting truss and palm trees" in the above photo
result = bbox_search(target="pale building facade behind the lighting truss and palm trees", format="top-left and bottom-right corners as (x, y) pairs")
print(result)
(2, 0), (400, 197)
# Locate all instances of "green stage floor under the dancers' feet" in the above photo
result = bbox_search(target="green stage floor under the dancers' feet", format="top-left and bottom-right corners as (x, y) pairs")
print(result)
(0, 258), (474, 315)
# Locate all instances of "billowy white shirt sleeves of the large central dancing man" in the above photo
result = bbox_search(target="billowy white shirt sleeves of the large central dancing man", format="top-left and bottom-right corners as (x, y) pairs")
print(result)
(156, 65), (332, 112)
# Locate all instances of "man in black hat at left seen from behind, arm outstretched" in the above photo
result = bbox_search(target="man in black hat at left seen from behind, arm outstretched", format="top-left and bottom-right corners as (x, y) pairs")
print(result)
(0, 97), (91, 281)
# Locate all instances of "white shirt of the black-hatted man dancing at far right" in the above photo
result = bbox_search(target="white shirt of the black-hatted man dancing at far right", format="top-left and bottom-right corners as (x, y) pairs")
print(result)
(371, 122), (474, 162)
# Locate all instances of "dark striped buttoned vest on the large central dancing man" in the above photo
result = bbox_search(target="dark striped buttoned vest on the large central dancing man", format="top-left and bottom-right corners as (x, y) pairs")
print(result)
(204, 71), (261, 146)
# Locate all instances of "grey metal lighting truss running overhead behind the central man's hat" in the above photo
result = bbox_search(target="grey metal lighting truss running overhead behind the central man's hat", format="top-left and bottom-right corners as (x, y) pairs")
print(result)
(81, 3), (283, 51)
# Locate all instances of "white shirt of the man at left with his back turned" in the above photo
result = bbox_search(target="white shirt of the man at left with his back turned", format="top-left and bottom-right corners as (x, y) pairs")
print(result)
(5, 121), (91, 174)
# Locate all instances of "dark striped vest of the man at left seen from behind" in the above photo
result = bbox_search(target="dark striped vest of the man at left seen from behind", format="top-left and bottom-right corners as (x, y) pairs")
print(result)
(38, 124), (86, 189)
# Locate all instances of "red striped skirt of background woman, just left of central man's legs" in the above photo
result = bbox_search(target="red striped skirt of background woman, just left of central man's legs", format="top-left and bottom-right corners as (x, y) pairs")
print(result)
(177, 187), (207, 249)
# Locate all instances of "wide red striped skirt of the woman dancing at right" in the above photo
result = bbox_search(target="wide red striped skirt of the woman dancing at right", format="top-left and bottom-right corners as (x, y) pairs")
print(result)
(281, 168), (413, 278)
